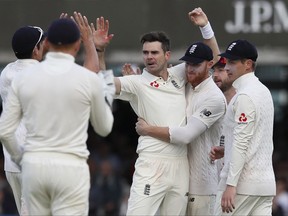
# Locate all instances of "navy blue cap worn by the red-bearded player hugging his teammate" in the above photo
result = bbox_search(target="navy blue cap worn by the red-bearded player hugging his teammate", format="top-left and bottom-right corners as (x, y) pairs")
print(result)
(179, 42), (213, 64)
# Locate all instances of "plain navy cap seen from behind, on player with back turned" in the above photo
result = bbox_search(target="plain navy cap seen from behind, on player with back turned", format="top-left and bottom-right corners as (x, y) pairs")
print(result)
(47, 19), (80, 45)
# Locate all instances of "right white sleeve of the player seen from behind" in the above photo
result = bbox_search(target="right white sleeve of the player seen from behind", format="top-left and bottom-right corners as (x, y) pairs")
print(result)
(90, 76), (114, 136)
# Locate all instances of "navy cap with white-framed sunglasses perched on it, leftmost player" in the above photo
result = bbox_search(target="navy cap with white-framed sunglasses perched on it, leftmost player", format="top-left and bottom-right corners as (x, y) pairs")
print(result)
(12, 26), (45, 55)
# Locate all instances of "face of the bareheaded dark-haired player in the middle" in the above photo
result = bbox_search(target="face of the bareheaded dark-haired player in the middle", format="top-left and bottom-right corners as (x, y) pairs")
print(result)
(142, 41), (170, 76)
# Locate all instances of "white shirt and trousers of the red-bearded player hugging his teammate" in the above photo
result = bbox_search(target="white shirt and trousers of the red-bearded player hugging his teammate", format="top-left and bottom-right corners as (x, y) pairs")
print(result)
(169, 76), (226, 215)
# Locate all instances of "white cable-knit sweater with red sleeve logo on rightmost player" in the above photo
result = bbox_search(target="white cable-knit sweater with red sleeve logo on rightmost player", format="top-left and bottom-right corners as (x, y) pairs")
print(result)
(219, 72), (276, 196)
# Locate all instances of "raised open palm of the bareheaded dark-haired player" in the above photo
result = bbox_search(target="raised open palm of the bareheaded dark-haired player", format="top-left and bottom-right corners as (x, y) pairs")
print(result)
(90, 17), (114, 52)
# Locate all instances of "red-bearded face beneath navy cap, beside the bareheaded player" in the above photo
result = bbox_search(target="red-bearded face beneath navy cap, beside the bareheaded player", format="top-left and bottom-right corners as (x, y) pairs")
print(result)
(185, 61), (213, 88)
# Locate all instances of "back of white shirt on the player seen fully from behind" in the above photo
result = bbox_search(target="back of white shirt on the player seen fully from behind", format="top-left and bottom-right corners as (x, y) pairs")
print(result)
(14, 53), (103, 157)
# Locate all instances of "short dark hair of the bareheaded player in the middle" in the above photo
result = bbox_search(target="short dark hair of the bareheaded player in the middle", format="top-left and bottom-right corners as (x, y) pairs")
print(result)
(140, 31), (170, 52)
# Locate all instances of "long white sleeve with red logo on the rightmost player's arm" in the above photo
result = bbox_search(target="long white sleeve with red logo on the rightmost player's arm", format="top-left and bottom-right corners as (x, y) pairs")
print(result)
(226, 94), (256, 186)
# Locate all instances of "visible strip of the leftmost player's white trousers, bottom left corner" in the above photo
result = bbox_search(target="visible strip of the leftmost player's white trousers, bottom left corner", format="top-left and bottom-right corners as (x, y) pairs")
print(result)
(5, 171), (21, 215)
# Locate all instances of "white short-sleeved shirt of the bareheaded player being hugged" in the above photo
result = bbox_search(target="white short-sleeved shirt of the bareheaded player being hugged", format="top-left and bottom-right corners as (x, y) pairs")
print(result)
(116, 64), (187, 157)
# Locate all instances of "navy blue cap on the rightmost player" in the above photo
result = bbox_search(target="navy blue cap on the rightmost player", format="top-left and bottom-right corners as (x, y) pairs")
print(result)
(220, 40), (258, 61)
